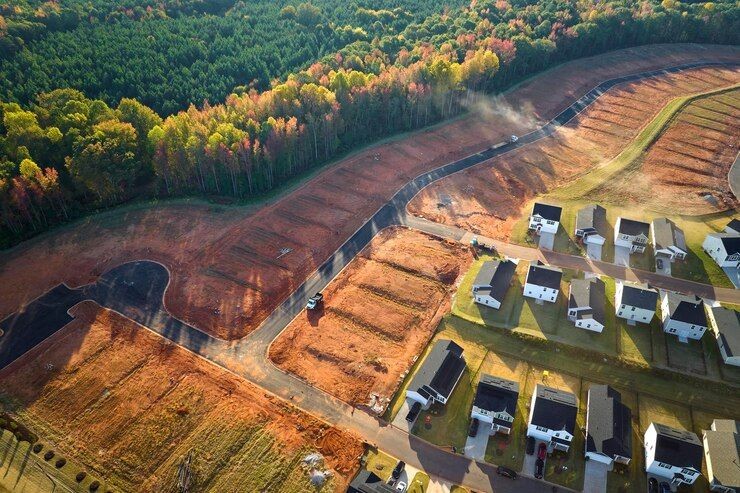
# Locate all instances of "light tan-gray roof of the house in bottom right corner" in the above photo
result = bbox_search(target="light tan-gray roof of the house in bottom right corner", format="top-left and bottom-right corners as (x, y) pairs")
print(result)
(704, 419), (740, 491)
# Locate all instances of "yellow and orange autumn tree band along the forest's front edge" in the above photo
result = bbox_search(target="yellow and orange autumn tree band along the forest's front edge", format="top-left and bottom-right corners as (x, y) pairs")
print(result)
(0, 0), (740, 244)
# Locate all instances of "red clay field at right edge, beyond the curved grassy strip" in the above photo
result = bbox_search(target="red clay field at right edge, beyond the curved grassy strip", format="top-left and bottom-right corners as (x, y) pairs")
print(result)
(593, 90), (740, 215)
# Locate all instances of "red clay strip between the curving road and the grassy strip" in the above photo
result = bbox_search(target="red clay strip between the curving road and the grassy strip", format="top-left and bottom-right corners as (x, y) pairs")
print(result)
(409, 64), (740, 239)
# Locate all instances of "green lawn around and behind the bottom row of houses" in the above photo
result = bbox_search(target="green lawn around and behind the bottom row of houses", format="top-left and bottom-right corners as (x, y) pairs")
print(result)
(392, 316), (740, 493)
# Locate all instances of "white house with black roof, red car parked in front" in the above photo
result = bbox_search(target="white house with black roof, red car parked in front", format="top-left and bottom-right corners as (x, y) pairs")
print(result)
(527, 384), (578, 452)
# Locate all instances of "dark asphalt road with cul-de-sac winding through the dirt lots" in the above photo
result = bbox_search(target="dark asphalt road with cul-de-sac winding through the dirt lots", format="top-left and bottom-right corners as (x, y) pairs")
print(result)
(0, 62), (737, 493)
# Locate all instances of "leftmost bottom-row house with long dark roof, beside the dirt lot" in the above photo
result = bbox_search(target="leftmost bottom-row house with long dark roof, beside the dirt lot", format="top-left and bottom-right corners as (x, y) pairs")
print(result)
(406, 339), (465, 409)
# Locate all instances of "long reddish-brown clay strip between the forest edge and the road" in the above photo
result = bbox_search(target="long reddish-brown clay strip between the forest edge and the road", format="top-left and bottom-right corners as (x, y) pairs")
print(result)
(0, 45), (740, 339)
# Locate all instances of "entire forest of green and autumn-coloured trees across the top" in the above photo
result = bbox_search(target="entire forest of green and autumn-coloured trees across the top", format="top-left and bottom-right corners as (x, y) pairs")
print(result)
(0, 0), (740, 247)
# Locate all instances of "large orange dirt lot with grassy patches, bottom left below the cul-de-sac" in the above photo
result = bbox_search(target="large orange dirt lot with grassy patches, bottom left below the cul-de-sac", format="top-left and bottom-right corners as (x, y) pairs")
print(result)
(0, 302), (363, 492)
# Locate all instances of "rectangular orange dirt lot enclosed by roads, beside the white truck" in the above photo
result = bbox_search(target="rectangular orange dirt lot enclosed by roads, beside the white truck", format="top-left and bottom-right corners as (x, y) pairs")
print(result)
(270, 228), (472, 404)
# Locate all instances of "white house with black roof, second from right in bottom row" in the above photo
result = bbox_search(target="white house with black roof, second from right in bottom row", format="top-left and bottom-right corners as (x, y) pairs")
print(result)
(645, 423), (704, 486)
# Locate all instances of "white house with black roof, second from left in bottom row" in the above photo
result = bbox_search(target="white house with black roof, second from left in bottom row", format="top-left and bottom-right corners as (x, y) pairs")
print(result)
(470, 374), (519, 435)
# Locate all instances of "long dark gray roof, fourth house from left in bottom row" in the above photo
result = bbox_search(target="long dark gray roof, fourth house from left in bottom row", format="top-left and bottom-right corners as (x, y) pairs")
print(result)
(586, 385), (632, 457)
